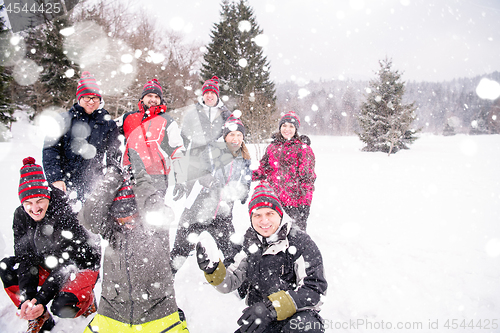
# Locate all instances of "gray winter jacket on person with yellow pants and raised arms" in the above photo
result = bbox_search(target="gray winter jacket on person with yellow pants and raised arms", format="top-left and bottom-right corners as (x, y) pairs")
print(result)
(79, 170), (177, 325)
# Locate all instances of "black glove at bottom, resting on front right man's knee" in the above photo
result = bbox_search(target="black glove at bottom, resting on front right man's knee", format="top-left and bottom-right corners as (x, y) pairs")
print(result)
(238, 300), (277, 333)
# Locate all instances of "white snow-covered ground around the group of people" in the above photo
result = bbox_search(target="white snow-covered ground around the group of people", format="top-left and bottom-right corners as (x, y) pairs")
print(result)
(0, 115), (500, 333)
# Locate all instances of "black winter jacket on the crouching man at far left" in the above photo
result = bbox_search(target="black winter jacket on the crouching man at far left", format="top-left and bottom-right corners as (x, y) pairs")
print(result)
(12, 186), (101, 305)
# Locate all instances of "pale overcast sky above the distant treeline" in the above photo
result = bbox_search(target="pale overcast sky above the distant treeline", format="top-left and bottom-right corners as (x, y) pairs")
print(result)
(141, 0), (500, 82)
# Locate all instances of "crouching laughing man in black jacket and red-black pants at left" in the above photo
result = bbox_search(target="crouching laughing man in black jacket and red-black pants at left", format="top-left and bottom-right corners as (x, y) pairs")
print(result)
(0, 157), (101, 333)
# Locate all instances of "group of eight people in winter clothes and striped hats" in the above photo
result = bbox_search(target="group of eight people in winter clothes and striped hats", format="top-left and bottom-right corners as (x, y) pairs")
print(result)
(0, 72), (327, 333)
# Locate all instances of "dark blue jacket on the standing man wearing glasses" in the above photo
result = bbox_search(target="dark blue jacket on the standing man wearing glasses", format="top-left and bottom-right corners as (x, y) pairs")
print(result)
(43, 104), (120, 199)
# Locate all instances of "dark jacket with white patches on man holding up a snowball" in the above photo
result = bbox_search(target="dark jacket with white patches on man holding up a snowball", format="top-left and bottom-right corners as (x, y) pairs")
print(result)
(215, 222), (328, 311)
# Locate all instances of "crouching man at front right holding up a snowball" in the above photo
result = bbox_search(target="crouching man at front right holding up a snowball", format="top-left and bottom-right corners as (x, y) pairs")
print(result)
(196, 181), (328, 333)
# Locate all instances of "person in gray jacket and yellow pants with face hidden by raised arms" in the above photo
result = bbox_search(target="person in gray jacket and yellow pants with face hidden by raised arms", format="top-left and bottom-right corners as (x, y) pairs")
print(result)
(78, 165), (188, 333)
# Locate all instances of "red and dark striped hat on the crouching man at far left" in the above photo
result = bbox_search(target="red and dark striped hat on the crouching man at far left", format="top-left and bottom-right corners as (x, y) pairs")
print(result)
(19, 157), (50, 203)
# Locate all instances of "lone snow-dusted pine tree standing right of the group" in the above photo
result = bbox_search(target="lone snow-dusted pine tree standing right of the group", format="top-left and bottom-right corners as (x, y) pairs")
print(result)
(357, 58), (418, 155)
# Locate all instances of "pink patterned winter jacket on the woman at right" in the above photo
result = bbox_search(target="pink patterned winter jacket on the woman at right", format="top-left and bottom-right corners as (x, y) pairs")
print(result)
(252, 138), (316, 207)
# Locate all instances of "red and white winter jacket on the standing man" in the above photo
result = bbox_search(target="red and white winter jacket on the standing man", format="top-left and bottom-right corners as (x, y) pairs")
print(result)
(122, 102), (184, 175)
